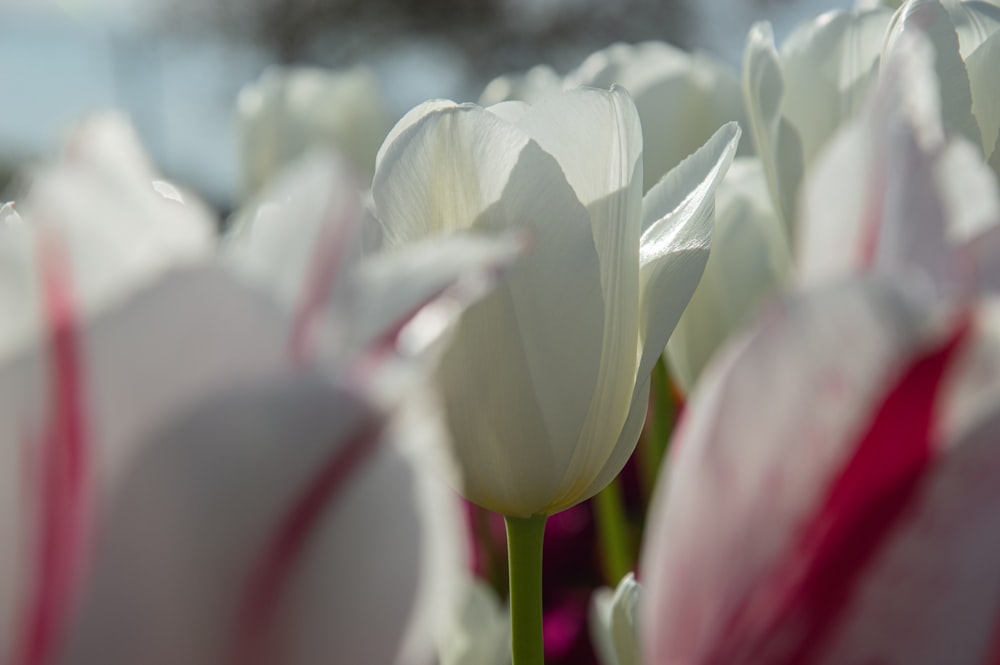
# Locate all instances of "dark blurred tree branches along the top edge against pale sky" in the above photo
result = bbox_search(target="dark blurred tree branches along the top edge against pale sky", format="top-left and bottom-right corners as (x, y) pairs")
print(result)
(164, 0), (685, 76)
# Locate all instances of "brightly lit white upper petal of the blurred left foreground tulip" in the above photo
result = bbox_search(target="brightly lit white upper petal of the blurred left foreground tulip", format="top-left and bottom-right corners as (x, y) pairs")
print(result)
(0, 114), (214, 361)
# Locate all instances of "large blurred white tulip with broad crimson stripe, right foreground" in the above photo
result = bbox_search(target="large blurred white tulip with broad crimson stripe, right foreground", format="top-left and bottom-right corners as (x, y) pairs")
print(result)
(642, 29), (1000, 665)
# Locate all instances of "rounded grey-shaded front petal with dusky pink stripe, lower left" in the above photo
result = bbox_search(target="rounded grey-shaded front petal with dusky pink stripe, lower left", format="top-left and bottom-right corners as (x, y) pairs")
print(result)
(63, 376), (440, 665)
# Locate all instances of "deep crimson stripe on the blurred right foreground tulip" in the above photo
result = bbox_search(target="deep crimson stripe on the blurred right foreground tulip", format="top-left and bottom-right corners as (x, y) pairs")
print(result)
(707, 322), (969, 665)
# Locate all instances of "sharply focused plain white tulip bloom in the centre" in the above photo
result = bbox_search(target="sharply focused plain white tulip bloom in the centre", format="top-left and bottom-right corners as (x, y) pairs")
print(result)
(372, 88), (739, 517)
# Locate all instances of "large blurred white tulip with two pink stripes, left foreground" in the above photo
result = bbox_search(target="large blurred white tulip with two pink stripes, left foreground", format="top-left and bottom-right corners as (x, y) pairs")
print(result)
(0, 114), (516, 665)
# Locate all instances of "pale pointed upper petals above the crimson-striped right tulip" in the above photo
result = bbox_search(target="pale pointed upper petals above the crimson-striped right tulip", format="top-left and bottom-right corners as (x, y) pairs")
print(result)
(800, 34), (1000, 297)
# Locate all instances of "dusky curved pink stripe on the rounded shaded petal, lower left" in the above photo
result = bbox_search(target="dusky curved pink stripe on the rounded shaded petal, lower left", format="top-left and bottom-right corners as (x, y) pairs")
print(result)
(229, 420), (382, 665)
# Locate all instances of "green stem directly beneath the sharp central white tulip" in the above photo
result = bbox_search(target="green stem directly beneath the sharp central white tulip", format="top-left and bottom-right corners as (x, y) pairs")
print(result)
(504, 515), (547, 665)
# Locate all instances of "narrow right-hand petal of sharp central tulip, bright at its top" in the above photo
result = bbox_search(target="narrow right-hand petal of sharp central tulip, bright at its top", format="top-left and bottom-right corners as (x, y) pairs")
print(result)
(508, 88), (642, 505)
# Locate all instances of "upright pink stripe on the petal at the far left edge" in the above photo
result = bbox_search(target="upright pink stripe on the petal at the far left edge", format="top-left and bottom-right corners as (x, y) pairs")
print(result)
(13, 236), (89, 665)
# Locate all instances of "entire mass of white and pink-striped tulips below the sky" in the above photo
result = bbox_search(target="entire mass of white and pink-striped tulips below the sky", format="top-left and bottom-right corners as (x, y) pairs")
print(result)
(0, 0), (1000, 665)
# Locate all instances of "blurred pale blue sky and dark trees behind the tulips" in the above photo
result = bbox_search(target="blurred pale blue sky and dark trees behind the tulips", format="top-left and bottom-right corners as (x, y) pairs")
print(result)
(0, 0), (853, 210)
